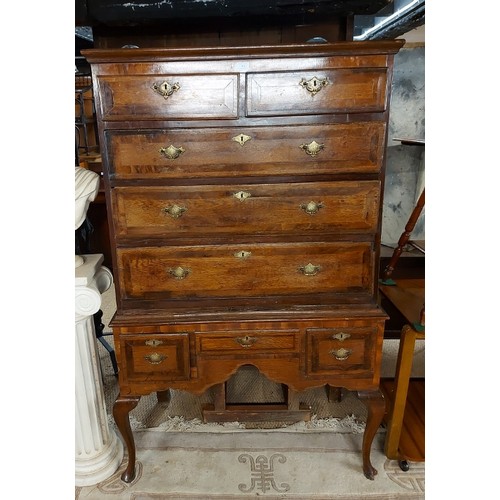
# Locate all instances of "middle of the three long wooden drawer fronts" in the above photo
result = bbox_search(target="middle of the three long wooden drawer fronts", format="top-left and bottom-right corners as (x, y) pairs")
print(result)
(112, 181), (380, 238)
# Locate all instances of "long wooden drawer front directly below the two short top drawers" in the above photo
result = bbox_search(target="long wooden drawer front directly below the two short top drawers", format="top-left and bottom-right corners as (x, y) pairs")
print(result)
(105, 122), (386, 179)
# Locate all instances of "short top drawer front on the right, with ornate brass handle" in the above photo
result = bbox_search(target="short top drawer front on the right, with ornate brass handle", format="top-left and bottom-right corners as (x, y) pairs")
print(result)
(247, 68), (387, 116)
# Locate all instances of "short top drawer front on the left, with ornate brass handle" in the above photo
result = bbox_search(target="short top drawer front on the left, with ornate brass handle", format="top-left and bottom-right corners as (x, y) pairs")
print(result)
(96, 74), (238, 121)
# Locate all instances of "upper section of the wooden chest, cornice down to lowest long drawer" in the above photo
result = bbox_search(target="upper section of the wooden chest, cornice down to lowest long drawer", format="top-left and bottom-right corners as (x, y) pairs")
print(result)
(82, 41), (404, 308)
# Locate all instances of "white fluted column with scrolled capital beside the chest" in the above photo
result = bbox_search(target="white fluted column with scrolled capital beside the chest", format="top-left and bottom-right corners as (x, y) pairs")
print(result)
(75, 254), (123, 486)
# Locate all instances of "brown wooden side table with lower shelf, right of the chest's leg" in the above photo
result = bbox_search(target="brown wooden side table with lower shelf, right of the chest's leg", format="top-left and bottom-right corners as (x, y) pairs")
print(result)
(379, 279), (425, 470)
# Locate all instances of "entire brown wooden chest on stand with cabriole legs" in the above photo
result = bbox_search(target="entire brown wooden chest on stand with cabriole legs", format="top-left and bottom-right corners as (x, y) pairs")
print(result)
(84, 41), (403, 482)
